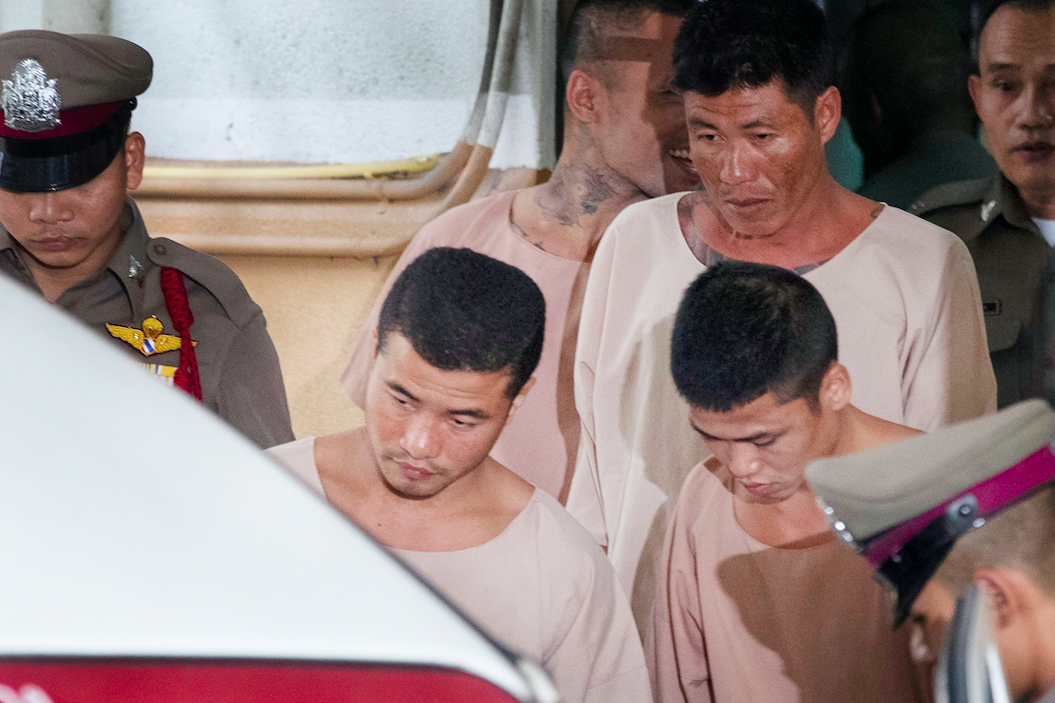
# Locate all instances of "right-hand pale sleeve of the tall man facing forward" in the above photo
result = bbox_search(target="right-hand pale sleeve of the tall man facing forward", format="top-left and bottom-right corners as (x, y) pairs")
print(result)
(902, 239), (996, 432)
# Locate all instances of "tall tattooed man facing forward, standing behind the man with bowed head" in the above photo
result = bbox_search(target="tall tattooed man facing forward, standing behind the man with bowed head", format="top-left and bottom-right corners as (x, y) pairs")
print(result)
(568, 0), (996, 622)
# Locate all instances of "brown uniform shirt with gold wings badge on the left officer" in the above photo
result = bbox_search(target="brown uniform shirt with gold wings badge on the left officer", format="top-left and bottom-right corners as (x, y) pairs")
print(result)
(0, 198), (293, 448)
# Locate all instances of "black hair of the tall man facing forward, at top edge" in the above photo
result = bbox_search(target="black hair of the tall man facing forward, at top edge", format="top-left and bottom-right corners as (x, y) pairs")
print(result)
(674, 0), (833, 110)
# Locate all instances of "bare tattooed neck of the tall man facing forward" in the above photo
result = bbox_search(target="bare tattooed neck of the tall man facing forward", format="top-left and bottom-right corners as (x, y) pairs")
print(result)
(678, 172), (883, 273)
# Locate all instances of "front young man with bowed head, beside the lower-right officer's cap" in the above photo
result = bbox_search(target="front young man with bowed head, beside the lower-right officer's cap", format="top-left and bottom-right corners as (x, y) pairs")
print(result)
(647, 263), (919, 703)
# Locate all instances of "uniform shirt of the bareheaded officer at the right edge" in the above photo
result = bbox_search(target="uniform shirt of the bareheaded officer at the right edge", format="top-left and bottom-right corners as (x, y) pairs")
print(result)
(909, 174), (1055, 407)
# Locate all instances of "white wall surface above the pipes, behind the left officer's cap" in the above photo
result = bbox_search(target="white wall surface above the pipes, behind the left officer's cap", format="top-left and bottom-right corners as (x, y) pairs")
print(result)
(110, 0), (490, 163)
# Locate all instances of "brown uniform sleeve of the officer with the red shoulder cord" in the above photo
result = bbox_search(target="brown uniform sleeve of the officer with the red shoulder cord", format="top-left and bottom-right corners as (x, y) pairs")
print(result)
(214, 312), (293, 449)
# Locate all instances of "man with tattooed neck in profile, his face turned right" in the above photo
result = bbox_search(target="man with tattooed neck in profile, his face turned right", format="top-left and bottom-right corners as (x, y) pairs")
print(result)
(342, 0), (698, 501)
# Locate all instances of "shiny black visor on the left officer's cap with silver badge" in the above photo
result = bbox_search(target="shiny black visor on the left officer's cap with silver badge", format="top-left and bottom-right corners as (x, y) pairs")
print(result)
(0, 108), (131, 193)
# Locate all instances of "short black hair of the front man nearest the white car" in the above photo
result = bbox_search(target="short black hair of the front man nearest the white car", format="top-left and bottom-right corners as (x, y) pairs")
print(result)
(378, 247), (545, 398)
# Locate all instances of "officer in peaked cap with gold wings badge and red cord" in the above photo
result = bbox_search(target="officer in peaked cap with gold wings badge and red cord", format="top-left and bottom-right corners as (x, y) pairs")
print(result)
(0, 30), (293, 448)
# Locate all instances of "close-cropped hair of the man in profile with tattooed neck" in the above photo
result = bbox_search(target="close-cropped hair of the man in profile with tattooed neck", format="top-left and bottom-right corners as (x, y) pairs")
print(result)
(558, 0), (695, 83)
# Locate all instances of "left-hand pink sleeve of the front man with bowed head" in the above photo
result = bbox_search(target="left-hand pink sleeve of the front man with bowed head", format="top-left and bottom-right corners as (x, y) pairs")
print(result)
(645, 491), (713, 703)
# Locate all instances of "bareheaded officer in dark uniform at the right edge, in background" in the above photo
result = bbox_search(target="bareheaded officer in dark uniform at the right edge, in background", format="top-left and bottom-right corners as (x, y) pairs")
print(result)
(908, 0), (1055, 407)
